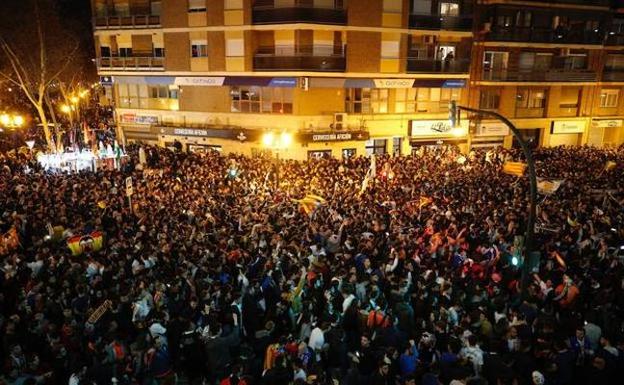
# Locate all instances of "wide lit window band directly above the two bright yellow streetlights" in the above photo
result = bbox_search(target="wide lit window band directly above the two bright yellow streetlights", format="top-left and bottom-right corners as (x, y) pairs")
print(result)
(230, 87), (293, 114)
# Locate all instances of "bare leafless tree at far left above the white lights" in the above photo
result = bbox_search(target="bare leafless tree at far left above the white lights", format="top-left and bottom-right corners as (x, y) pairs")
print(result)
(0, 0), (79, 150)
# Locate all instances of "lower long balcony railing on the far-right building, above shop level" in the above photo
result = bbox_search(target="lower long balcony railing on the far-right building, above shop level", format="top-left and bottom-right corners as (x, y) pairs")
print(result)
(482, 69), (598, 82)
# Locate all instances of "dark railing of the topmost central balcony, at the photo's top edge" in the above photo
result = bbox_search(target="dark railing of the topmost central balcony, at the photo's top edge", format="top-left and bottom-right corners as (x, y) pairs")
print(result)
(252, 4), (347, 25)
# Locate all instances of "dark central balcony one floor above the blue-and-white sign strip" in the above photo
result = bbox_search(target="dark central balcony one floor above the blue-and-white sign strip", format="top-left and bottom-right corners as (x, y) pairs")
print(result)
(254, 46), (347, 72)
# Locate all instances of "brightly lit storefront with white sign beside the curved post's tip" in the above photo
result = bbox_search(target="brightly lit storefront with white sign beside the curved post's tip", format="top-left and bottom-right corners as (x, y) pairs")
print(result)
(408, 120), (468, 151)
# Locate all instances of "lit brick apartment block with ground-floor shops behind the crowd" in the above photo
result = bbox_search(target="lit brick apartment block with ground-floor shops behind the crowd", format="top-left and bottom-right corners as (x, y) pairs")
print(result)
(92, 0), (624, 159)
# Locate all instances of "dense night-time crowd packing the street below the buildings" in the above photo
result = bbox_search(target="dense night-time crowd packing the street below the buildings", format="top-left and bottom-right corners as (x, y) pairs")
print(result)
(0, 142), (624, 385)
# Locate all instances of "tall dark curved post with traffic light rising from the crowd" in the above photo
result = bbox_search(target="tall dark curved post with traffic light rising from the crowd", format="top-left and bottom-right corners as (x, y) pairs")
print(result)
(449, 101), (537, 299)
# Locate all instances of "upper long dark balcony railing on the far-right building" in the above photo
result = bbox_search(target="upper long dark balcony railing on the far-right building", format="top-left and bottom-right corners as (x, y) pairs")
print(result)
(486, 27), (604, 44)
